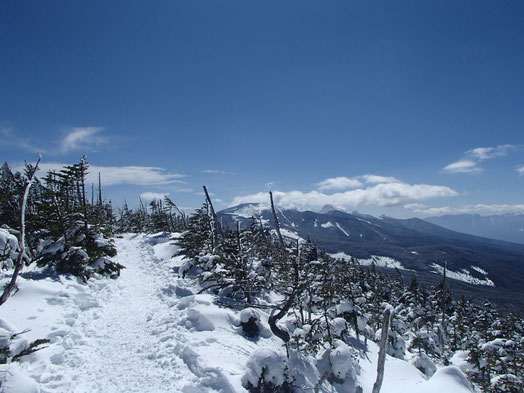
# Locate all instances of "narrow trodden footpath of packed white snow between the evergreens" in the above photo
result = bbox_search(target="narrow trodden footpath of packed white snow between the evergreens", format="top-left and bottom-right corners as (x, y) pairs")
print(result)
(52, 234), (194, 392)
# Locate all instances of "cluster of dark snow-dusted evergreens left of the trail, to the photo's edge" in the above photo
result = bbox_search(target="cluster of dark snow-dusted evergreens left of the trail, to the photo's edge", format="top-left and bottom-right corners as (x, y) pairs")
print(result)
(0, 158), (123, 280)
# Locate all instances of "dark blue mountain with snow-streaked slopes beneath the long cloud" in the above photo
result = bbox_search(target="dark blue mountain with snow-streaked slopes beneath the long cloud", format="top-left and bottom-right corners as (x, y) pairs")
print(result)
(218, 204), (524, 311)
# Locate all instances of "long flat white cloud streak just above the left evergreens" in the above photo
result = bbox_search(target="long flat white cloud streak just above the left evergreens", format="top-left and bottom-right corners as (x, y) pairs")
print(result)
(18, 162), (185, 186)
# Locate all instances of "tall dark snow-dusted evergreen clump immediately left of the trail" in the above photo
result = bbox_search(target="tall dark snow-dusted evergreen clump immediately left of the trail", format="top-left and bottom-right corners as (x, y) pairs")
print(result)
(35, 159), (123, 280)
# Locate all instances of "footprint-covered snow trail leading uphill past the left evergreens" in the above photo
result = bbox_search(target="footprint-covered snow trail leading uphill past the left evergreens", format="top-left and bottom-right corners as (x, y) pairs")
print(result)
(34, 234), (206, 393)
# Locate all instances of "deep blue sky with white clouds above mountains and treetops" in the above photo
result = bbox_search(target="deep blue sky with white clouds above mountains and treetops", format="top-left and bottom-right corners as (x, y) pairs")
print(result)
(0, 0), (524, 217)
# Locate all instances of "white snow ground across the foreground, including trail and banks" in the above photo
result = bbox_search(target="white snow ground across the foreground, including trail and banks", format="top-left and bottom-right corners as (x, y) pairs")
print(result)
(0, 234), (471, 393)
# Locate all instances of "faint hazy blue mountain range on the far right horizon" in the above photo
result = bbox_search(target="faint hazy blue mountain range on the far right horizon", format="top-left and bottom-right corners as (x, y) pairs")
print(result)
(424, 214), (524, 244)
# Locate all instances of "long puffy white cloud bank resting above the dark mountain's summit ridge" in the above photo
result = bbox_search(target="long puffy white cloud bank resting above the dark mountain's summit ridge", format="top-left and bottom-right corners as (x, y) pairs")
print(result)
(231, 183), (458, 211)
